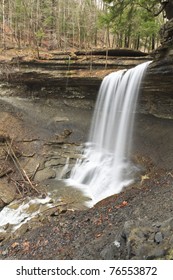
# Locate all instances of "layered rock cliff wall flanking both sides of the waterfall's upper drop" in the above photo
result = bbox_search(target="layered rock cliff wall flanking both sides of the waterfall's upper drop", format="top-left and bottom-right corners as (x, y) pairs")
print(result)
(1, 37), (173, 169)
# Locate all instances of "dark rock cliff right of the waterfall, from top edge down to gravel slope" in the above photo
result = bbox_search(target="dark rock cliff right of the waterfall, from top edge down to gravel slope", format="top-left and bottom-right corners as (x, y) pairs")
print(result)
(134, 17), (173, 169)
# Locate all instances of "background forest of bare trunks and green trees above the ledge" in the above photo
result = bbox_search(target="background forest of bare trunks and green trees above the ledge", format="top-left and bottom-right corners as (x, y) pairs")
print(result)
(0, 0), (164, 52)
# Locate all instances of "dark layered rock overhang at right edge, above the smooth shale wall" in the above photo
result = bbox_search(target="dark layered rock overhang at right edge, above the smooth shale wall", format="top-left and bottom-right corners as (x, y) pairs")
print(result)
(147, 13), (173, 119)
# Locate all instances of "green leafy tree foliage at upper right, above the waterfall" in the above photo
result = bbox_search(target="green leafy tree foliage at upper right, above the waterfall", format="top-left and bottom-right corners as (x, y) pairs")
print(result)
(101, 0), (164, 51)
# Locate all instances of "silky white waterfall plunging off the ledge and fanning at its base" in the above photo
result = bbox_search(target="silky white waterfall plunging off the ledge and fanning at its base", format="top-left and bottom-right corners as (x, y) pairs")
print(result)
(68, 62), (150, 204)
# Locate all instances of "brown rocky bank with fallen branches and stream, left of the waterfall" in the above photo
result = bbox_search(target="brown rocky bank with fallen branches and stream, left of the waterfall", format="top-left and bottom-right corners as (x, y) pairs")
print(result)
(0, 90), (93, 240)
